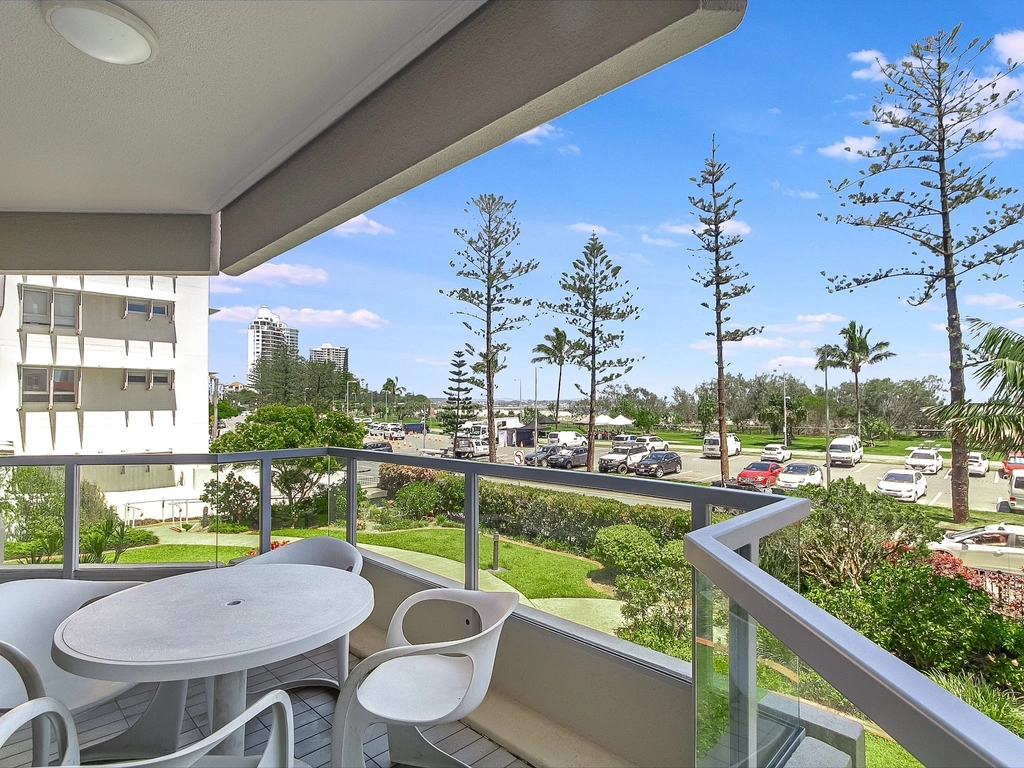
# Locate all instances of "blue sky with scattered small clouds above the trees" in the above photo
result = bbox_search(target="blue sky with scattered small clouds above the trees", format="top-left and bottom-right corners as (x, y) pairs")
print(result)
(210, 0), (1024, 400)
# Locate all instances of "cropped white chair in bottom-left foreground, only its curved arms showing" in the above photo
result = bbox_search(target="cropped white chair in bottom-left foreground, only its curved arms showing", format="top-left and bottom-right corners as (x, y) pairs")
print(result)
(0, 690), (308, 768)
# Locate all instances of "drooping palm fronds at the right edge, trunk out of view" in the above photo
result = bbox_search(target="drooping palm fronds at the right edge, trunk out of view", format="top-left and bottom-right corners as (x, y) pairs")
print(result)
(926, 322), (1024, 452)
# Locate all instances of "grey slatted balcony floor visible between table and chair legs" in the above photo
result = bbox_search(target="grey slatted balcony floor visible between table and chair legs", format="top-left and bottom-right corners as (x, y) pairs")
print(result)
(0, 645), (528, 768)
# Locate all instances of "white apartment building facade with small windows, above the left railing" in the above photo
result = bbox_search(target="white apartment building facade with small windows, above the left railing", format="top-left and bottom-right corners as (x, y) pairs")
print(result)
(0, 274), (209, 455)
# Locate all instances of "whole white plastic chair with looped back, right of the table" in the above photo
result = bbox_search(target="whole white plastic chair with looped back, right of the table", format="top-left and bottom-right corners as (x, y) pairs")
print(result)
(331, 589), (519, 768)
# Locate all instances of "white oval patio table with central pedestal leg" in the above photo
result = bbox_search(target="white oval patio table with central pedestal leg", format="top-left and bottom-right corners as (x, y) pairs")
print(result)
(52, 564), (374, 755)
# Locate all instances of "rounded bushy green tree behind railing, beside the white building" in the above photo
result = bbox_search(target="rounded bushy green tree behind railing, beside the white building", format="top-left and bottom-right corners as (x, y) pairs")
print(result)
(210, 406), (365, 505)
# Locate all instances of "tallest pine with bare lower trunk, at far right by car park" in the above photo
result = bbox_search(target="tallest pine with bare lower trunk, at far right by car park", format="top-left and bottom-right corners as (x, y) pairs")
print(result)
(822, 25), (1024, 522)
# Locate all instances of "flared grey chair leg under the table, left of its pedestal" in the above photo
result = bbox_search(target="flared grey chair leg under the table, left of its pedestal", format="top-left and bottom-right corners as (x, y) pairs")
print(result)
(82, 680), (187, 763)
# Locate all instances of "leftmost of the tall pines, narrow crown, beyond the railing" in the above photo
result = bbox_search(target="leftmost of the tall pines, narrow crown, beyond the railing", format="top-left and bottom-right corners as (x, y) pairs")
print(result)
(441, 195), (540, 462)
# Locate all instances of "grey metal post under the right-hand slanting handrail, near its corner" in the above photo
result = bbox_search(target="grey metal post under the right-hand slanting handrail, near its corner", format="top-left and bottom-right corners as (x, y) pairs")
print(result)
(729, 541), (758, 768)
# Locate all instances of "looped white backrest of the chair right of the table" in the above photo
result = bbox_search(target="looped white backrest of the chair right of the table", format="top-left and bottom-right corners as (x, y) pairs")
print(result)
(385, 589), (519, 720)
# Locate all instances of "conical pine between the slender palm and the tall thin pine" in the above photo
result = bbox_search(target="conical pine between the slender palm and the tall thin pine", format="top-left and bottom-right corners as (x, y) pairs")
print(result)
(541, 234), (640, 472)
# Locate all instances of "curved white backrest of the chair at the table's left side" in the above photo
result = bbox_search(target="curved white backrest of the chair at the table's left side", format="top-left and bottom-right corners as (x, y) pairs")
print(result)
(0, 579), (139, 707)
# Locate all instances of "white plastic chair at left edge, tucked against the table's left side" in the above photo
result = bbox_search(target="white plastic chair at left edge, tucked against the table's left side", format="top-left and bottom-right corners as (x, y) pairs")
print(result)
(0, 579), (146, 765)
